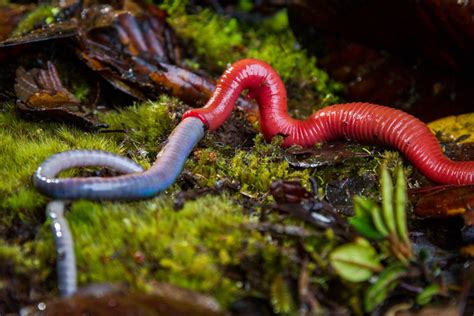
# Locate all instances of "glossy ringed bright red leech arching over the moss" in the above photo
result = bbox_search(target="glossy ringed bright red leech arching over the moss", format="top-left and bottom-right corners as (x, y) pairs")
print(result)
(183, 59), (474, 184)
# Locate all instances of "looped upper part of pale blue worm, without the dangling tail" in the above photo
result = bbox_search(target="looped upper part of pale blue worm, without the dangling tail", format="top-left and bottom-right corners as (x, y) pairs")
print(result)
(33, 117), (204, 200)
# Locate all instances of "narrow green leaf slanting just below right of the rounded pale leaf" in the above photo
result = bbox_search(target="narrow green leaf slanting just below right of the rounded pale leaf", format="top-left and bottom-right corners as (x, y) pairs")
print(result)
(364, 263), (406, 312)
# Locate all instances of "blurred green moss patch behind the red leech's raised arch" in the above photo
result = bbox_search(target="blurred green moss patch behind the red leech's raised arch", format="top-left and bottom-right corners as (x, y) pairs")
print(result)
(169, 7), (342, 115)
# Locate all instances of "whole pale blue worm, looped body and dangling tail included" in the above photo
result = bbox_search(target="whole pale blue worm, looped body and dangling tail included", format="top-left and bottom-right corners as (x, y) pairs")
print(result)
(38, 118), (204, 297)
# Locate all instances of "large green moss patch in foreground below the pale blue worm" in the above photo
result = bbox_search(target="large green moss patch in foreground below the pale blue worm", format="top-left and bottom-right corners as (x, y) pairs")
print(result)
(34, 196), (282, 303)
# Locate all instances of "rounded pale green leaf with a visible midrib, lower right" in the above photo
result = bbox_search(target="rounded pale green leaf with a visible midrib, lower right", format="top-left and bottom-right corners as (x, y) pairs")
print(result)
(330, 238), (383, 282)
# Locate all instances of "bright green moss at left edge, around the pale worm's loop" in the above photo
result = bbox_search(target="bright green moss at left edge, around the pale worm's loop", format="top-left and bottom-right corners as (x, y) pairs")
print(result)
(0, 105), (122, 222)
